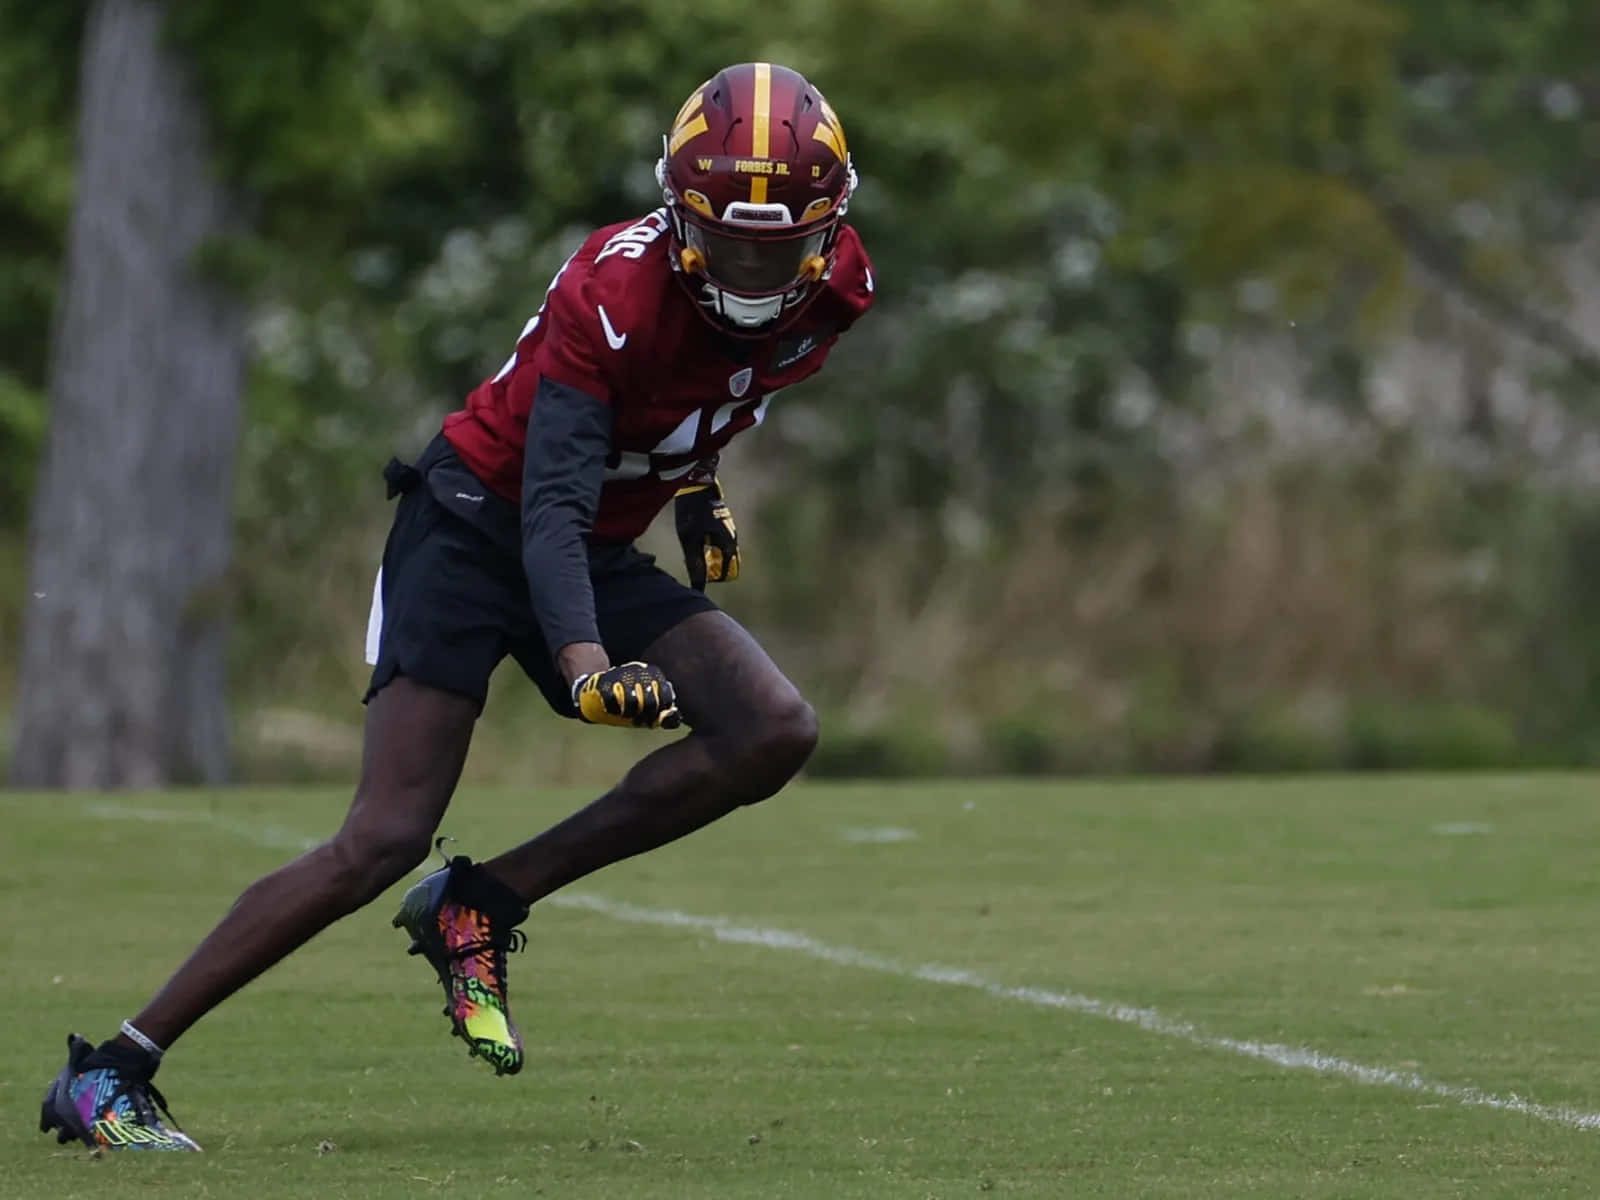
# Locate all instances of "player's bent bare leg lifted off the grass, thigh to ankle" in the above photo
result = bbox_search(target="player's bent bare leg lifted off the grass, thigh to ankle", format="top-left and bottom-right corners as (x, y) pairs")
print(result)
(485, 611), (818, 902)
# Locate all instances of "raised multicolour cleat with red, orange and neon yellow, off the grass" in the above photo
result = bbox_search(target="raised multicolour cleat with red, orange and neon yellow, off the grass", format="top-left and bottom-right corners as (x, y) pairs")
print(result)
(394, 854), (528, 1075)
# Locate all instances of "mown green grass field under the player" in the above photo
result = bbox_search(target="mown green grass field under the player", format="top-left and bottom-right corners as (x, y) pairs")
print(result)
(0, 774), (1600, 1200)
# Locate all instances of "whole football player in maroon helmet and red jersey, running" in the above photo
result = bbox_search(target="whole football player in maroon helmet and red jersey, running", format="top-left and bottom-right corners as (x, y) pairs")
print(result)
(42, 62), (872, 1150)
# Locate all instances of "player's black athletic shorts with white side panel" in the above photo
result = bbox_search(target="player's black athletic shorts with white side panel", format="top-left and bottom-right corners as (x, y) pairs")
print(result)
(366, 437), (715, 717)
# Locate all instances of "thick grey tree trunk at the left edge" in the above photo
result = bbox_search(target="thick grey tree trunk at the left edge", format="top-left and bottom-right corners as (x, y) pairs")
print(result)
(11, 0), (245, 787)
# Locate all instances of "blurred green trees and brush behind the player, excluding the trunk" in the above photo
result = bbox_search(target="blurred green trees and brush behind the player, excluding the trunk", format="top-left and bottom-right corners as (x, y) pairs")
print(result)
(0, 0), (1600, 774)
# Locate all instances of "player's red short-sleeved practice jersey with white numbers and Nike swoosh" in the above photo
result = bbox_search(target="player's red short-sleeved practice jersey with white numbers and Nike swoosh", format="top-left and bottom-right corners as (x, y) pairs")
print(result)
(443, 210), (872, 542)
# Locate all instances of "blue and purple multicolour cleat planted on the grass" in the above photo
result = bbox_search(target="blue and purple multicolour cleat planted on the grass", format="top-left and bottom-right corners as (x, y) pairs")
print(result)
(38, 1034), (200, 1150)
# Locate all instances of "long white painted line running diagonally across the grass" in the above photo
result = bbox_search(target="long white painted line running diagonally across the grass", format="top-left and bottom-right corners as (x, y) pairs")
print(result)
(88, 803), (1600, 1130)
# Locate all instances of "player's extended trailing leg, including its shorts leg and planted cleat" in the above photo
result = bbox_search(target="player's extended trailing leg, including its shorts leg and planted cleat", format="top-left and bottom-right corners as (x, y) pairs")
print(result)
(40, 438), (506, 1149)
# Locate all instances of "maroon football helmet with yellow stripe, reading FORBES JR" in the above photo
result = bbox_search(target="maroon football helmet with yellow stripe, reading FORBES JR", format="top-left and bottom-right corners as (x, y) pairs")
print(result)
(656, 62), (856, 338)
